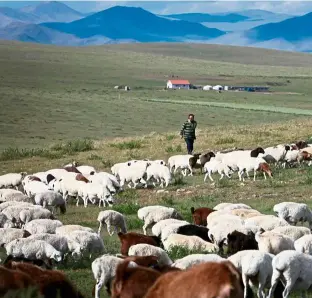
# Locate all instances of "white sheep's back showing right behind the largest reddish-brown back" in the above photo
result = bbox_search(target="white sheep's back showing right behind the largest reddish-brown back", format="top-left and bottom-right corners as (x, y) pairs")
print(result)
(172, 254), (225, 270)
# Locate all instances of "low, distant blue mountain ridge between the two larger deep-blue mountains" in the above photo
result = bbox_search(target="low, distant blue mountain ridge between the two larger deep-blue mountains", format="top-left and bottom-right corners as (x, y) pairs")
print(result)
(165, 13), (248, 23)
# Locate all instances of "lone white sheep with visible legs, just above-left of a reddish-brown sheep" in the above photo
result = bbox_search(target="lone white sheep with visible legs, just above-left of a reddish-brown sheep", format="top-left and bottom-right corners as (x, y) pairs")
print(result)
(97, 210), (127, 236)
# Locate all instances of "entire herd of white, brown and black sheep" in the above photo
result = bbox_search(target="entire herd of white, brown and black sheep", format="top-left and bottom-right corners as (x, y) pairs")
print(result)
(0, 141), (312, 298)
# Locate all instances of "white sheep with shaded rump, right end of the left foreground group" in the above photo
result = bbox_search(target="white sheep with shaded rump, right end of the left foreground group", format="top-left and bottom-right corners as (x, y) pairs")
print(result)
(64, 230), (105, 258)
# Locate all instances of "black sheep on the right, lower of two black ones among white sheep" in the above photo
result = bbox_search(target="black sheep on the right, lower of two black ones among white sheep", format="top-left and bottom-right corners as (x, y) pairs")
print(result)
(224, 230), (259, 255)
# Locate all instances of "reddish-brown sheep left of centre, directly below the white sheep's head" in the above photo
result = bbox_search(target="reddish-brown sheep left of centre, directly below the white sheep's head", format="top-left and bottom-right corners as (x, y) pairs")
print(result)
(118, 232), (161, 256)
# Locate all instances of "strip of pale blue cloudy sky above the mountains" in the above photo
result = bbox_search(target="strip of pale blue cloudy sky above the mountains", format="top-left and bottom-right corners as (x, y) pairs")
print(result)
(0, 0), (312, 15)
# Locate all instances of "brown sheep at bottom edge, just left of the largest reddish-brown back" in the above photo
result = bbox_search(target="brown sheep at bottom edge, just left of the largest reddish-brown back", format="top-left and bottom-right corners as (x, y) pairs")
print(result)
(111, 261), (180, 298)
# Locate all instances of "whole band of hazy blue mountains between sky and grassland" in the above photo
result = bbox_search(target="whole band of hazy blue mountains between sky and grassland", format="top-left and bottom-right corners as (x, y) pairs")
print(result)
(0, 1), (312, 52)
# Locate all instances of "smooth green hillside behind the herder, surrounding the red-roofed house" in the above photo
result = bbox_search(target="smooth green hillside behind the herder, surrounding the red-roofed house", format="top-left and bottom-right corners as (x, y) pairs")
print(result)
(0, 42), (312, 149)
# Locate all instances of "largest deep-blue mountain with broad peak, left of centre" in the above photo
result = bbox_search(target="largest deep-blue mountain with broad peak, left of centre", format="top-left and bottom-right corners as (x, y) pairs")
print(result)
(41, 6), (225, 42)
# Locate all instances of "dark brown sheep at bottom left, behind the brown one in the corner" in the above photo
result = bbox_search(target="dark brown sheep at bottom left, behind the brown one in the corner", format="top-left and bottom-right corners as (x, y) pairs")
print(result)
(5, 261), (84, 298)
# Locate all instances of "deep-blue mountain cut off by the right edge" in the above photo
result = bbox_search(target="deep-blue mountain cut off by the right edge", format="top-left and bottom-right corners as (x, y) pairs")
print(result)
(245, 12), (312, 42)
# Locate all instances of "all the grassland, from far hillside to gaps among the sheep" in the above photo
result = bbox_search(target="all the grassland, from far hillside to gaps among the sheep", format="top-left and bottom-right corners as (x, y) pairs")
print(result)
(0, 42), (312, 297)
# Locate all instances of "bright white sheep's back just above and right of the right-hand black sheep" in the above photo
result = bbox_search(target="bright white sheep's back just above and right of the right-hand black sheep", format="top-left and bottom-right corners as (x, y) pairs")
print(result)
(244, 215), (289, 231)
